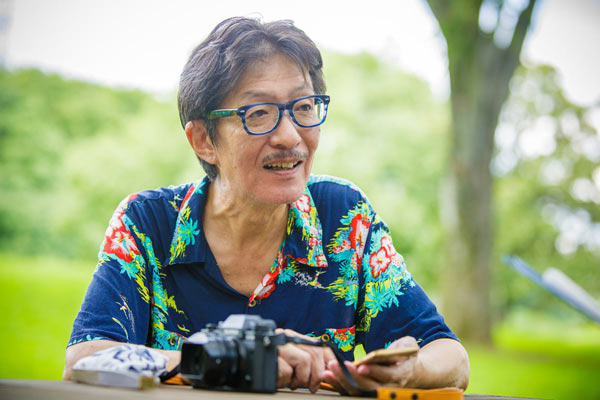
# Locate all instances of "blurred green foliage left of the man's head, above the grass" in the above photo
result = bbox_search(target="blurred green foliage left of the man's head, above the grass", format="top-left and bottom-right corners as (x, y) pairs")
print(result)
(0, 69), (198, 257)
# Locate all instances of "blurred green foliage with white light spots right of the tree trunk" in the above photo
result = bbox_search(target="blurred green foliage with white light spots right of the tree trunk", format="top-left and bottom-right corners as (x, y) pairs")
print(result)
(492, 66), (600, 312)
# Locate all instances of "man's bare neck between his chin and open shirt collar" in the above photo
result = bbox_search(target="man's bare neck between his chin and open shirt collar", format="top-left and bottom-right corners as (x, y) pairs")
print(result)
(203, 178), (289, 250)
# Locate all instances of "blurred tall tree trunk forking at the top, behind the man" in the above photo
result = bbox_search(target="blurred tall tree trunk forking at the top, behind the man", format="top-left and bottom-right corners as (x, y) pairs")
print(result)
(428, 0), (535, 342)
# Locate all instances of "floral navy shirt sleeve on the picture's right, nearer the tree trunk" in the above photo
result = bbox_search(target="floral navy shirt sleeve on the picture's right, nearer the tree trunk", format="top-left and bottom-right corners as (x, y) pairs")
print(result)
(357, 212), (458, 351)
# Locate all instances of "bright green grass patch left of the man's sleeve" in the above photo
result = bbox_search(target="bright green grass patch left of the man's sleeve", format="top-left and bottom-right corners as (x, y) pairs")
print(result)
(0, 255), (94, 379)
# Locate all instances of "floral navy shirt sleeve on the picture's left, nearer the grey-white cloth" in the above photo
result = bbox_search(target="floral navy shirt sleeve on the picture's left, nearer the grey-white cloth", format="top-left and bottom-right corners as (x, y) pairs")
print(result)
(67, 195), (150, 346)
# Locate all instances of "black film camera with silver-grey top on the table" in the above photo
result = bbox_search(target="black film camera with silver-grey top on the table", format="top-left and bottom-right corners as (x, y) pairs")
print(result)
(181, 314), (285, 393)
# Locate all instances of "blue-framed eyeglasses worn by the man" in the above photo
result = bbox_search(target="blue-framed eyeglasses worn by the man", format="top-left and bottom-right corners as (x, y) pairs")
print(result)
(206, 94), (330, 135)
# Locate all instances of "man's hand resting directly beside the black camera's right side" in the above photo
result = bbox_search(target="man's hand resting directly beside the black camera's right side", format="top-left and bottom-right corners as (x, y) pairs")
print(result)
(276, 329), (335, 393)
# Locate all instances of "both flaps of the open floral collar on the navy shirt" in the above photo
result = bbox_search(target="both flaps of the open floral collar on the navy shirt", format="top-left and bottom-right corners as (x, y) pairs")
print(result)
(168, 177), (327, 268)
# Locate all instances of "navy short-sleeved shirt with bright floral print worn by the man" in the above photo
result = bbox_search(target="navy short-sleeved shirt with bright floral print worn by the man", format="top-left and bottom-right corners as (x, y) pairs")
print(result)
(69, 176), (456, 359)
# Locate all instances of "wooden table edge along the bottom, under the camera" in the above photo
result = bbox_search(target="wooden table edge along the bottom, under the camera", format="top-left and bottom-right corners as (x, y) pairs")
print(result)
(0, 380), (548, 400)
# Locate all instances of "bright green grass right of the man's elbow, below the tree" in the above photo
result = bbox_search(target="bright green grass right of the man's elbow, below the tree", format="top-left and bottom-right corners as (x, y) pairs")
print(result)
(465, 312), (600, 400)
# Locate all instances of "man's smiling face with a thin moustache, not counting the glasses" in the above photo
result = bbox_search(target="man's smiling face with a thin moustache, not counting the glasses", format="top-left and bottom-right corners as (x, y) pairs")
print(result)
(209, 54), (321, 204)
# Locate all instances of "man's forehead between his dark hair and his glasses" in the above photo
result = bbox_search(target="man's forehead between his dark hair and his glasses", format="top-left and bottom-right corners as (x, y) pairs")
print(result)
(225, 53), (313, 103)
